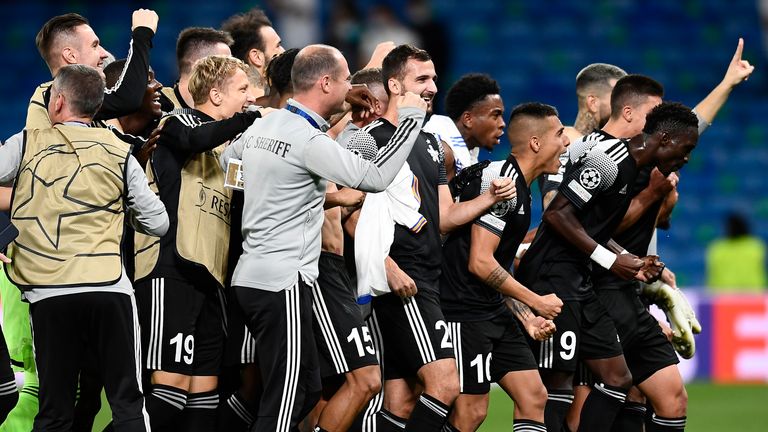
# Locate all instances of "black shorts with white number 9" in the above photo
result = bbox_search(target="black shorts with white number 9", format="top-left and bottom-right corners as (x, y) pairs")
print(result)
(531, 297), (622, 372)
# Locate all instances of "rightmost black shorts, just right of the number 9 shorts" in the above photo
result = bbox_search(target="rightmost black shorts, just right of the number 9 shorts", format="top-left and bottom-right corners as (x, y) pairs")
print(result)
(597, 282), (680, 384)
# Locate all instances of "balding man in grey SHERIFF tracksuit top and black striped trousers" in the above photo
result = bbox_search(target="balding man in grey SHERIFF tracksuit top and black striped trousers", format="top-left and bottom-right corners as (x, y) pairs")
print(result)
(221, 45), (426, 431)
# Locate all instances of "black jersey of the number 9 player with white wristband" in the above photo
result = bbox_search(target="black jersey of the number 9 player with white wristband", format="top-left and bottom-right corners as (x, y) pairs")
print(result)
(518, 131), (638, 300)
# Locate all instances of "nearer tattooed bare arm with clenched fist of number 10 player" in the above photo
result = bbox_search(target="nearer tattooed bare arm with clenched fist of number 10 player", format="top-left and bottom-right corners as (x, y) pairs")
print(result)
(469, 224), (563, 319)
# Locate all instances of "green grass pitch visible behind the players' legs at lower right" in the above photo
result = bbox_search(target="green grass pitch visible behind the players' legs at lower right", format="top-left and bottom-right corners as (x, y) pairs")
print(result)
(480, 382), (768, 432)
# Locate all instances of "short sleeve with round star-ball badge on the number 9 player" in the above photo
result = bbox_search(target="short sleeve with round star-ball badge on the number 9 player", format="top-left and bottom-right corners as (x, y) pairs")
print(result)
(559, 152), (619, 209)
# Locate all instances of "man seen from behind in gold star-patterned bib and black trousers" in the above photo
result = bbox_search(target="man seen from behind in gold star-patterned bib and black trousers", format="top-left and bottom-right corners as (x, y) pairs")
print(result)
(0, 65), (168, 431)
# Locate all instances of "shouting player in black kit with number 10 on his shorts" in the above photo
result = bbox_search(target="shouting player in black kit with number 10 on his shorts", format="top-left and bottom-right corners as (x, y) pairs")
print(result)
(440, 102), (569, 431)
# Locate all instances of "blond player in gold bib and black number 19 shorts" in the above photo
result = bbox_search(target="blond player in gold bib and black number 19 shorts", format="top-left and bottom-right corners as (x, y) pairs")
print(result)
(136, 56), (259, 431)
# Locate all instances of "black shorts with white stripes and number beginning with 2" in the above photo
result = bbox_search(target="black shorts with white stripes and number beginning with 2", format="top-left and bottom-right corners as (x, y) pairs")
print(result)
(372, 281), (454, 380)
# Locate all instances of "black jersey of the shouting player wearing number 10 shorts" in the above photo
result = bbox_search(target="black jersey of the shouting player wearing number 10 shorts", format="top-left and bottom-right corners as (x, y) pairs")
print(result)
(440, 155), (531, 321)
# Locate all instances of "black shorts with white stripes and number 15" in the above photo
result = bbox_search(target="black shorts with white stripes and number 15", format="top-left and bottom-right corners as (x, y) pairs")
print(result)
(312, 252), (379, 378)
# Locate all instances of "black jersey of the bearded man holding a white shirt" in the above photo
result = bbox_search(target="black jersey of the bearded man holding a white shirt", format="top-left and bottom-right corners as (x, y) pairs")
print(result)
(363, 118), (448, 288)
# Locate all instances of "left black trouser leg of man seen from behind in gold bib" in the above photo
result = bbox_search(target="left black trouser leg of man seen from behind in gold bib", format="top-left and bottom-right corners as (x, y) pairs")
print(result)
(29, 294), (87, 432)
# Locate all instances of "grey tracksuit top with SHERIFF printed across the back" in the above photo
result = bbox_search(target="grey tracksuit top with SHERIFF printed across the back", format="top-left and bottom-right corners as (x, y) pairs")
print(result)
(221, 99), (425, 291)
